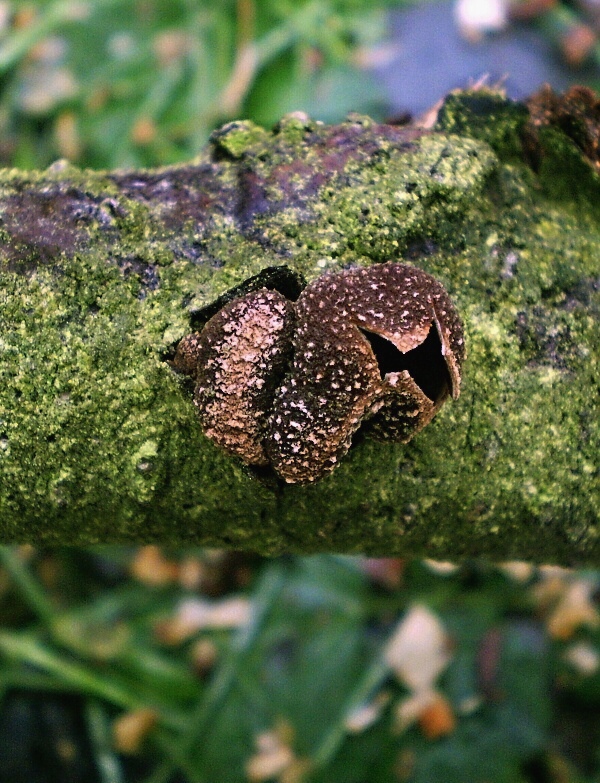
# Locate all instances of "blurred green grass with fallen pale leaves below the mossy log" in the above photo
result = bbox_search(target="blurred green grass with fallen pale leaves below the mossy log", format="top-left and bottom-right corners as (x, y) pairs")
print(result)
(0, 547), (600, 783)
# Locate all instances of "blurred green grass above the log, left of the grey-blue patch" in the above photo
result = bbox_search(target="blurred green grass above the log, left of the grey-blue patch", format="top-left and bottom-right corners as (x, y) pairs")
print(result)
(0, 0), (402, 168)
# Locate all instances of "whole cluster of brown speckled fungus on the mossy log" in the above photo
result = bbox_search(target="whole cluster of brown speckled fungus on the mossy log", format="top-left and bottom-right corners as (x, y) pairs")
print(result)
(173, 263), (464, 484)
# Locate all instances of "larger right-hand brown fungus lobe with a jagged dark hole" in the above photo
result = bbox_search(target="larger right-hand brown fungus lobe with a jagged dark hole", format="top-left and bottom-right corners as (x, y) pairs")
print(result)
(266, 264), (464, 483)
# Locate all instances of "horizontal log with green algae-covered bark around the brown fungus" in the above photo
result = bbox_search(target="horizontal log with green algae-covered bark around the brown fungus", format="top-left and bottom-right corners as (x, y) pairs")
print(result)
(0, 93), (600, 563)
